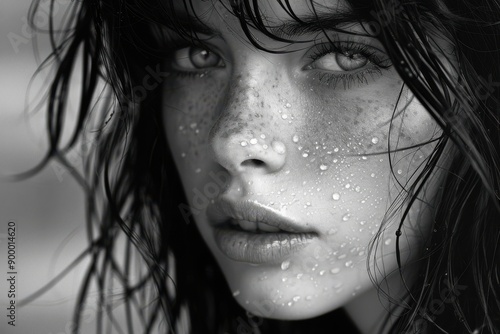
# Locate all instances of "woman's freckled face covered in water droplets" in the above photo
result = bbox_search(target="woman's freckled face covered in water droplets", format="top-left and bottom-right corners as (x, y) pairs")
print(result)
(163, 0), (439, 319)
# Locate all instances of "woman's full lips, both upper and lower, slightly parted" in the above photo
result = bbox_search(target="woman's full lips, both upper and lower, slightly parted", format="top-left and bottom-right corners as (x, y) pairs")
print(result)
(207, 199), (318, 264)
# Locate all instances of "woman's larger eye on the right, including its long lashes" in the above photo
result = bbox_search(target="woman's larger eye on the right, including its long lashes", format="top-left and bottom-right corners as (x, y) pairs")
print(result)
(304, 41), (392, 89)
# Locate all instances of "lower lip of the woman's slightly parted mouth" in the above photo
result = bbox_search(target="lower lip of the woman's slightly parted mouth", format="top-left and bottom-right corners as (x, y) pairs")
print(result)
(214, 225), (317, 264)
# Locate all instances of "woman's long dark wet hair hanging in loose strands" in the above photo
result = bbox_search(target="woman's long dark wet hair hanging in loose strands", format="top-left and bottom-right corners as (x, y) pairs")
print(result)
(26, 0), (500, 334)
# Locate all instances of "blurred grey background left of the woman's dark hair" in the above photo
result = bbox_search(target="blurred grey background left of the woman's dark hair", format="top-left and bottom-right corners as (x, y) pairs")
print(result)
(0, 0), (102, 334)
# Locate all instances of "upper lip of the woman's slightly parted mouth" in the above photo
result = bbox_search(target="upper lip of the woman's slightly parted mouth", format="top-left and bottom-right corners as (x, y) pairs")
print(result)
(207, 198), (312, 233)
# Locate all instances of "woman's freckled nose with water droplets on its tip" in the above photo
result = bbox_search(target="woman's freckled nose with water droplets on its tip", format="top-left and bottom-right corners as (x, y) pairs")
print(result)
(210, 71), (287, 174)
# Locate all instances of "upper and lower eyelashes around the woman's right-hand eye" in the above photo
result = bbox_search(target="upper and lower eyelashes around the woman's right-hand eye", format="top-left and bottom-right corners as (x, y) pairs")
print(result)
(308, 41), (392, 89)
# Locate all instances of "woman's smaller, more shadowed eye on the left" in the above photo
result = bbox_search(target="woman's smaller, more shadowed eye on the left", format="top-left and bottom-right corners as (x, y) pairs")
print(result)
(168, 45), (225, 74)
